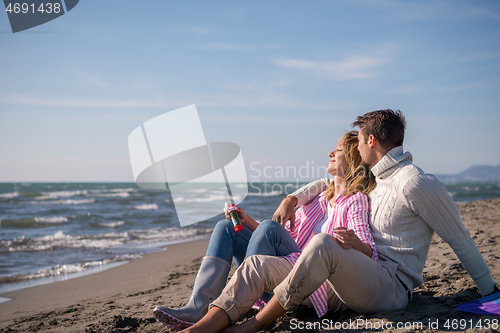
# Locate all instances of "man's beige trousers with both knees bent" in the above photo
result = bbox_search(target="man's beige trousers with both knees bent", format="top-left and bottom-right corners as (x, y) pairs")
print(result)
(210, 233), (408, 323)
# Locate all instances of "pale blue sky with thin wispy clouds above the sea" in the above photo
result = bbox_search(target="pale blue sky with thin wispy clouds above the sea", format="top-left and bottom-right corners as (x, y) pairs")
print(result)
(0, 0), (500, 182)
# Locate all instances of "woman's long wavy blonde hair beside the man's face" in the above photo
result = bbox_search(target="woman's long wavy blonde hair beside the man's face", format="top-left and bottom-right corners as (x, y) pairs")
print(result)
(325, 131), (376, 200)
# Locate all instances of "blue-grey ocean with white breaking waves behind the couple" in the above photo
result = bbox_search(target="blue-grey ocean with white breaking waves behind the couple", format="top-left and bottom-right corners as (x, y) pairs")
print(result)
(0, 182), (500, 294)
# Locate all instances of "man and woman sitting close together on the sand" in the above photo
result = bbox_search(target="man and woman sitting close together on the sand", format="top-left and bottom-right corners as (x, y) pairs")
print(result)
(154, 110), (498, 333)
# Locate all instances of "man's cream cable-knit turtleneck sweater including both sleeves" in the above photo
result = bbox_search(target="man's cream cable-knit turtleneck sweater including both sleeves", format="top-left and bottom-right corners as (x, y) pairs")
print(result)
(291, 146), (495, 295)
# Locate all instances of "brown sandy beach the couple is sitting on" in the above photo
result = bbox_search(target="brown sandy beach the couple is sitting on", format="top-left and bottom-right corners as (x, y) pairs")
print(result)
(0, 199), (500, 332)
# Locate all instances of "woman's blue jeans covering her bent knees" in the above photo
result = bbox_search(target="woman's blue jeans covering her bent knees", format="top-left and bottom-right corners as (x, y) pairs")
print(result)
(207, 219), (300, 266)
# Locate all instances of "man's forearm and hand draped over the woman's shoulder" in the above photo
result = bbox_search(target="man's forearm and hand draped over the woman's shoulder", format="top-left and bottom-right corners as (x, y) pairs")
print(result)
(273, 178), (331, 231)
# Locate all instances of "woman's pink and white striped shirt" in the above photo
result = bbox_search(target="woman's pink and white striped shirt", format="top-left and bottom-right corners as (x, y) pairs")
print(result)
(284, 192), (378, 317)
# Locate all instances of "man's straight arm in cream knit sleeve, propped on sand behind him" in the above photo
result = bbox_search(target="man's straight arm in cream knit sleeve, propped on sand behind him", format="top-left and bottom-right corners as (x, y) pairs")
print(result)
(404, 174), (496, 295)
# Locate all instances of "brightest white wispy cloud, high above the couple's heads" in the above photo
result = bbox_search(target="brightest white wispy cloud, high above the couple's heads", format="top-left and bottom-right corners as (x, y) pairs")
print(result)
(274, 55), (386, 81)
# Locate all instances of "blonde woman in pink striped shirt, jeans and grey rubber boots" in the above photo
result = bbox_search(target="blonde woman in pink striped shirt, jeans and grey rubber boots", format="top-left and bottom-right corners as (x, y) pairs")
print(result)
(154, 131), (377, 329)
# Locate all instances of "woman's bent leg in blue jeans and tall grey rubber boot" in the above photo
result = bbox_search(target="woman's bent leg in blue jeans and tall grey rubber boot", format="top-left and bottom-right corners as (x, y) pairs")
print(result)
(153, 220), (252, 330)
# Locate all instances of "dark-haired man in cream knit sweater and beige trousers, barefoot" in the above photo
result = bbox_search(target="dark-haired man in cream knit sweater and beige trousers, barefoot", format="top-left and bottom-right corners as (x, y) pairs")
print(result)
(179, 110), (498, 332)
